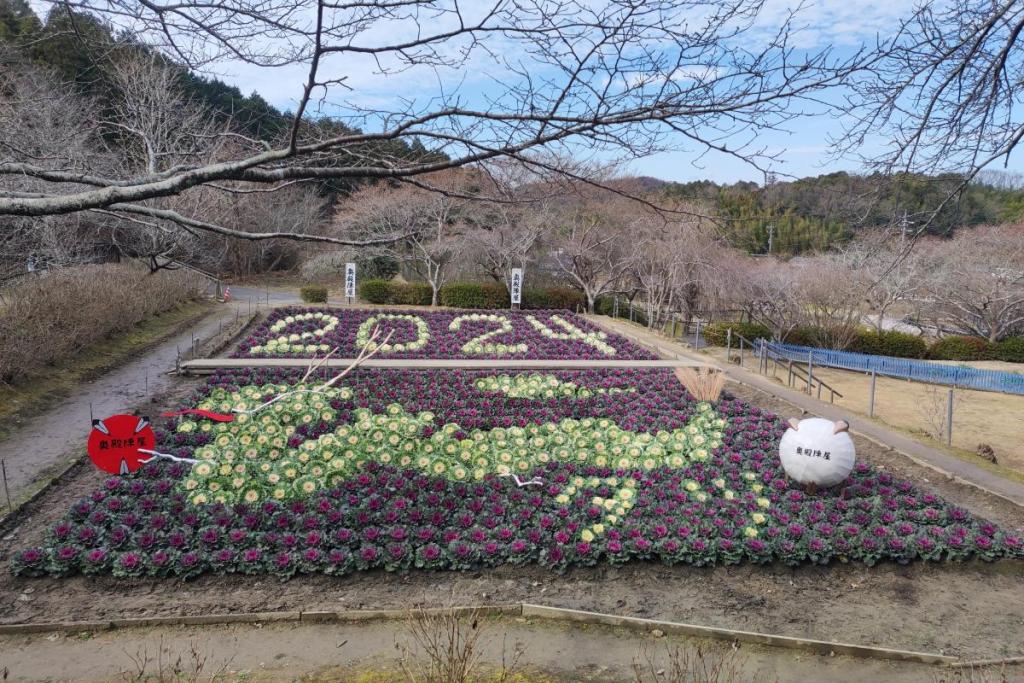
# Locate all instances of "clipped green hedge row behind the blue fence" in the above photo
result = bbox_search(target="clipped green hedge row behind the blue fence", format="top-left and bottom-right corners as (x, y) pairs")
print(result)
(703, 323), (1024, 362)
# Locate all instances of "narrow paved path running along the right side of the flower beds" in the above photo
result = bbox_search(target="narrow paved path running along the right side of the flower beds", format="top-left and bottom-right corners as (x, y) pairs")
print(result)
(590, 316), (1024, 506)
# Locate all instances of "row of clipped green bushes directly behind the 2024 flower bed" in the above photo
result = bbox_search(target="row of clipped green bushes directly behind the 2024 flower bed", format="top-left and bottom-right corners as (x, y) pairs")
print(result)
(359, 280), (584, 310)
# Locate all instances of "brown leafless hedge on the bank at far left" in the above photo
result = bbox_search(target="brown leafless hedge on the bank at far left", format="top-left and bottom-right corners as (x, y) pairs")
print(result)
(0, 264), (203, 382)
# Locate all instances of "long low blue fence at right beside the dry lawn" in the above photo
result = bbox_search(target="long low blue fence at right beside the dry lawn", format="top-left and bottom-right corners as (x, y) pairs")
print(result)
(761, 342), (1024, 395)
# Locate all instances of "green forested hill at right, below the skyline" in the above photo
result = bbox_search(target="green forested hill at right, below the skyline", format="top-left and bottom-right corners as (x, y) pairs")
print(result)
(662, 172), (1024, 254)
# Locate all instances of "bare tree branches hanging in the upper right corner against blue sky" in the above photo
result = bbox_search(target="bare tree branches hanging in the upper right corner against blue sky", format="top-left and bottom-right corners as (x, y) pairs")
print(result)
(839, 0), (1024, 235)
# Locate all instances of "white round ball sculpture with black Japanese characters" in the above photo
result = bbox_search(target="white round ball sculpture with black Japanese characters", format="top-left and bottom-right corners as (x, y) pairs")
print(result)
(778, 418), (856, 488)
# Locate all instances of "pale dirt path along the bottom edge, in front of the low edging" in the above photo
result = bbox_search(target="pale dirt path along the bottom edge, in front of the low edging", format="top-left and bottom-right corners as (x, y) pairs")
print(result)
(0, 618), (940, 683)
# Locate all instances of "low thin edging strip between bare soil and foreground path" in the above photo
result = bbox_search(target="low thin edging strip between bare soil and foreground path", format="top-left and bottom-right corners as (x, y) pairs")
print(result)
(0, 603), (966, 666)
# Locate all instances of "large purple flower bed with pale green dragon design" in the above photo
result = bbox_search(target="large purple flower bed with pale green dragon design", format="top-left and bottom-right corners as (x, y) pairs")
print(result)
(13, 370), (1024, 578)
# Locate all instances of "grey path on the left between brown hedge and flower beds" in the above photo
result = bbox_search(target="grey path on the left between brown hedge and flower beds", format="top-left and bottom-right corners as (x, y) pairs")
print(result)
(0, 306), (238, 501)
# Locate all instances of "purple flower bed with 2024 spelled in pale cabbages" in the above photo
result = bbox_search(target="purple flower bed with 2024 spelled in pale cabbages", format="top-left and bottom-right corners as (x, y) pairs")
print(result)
(234, 307), (654, 359)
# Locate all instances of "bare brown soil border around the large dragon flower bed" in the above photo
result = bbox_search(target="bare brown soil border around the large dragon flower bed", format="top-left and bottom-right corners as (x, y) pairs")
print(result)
(0, 333), (1024, 663)
